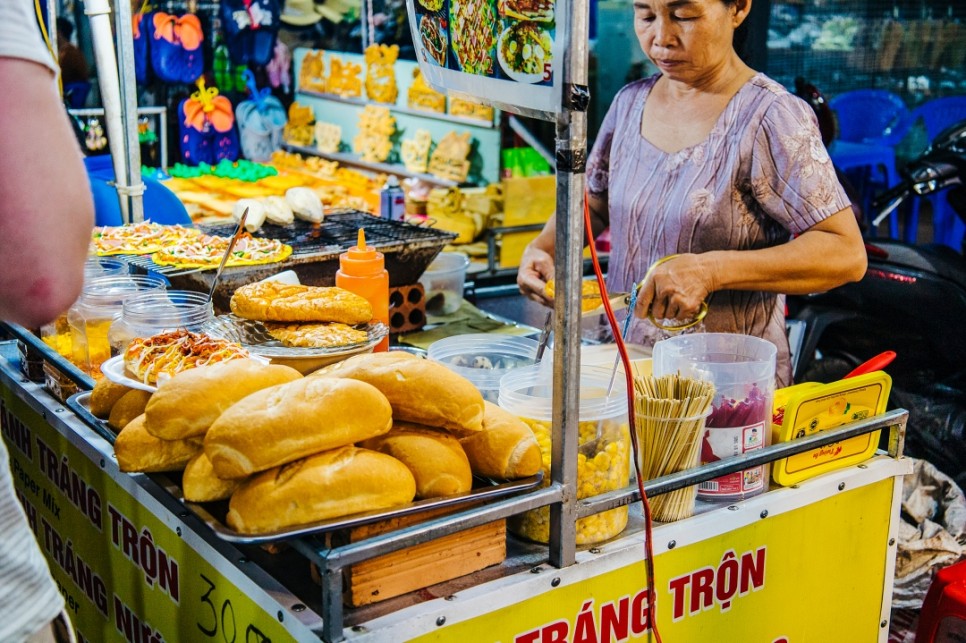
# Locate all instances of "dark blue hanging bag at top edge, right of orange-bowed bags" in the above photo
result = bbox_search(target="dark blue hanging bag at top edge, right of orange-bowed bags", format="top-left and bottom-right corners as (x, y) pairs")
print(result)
(221, 0), (281, 67)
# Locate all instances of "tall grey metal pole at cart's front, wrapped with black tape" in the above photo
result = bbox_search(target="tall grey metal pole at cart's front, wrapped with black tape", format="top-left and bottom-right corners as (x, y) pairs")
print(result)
(550, 0), (589, 567)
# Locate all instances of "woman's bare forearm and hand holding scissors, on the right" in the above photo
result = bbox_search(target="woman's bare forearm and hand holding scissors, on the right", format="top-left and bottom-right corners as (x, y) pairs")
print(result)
(634, 208), (867, 319)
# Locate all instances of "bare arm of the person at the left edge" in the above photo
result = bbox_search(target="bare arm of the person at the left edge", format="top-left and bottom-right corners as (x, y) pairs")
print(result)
(0, 58), (94, 327)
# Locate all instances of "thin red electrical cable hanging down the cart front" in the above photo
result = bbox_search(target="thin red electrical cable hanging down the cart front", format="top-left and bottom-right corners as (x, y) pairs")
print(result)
(584, 191), (662, 643)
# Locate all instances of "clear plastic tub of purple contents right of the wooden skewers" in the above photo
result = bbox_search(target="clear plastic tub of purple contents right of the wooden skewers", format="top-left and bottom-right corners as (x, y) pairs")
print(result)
(654, 333), (778, 502)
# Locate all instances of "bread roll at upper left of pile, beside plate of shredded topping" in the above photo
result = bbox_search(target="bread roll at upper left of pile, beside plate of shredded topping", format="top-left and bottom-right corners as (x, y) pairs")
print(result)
(144, 359), (302, 440)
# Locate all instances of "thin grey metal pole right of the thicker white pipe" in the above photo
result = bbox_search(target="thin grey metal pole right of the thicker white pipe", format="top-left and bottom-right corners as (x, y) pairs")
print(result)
(114, 2), (144, 223)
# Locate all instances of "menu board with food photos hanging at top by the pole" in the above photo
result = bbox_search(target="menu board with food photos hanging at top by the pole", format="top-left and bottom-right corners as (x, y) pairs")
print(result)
(408, 0), (567, 118)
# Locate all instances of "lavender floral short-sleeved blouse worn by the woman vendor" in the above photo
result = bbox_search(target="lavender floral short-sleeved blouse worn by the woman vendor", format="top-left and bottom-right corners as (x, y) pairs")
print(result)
(587, 74), (850, 386)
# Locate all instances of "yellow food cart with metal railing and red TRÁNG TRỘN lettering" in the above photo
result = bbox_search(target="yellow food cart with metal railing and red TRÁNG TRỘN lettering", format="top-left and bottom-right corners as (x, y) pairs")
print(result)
(0, 327), (910, 643)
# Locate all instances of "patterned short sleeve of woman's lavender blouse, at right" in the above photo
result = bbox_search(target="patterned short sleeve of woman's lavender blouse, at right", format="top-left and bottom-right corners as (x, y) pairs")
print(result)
(751, 94), (850, 234)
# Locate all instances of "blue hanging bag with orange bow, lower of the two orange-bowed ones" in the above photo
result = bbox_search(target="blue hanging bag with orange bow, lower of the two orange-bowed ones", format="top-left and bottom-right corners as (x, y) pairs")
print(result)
(178, 77), (238, 165)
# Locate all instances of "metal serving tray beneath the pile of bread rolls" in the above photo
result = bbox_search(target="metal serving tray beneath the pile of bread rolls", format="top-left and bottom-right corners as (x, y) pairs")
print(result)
(67, 391), (543, 545)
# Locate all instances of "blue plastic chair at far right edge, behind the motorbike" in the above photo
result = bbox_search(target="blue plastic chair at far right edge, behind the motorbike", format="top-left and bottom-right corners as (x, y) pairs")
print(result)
(904, 96), (966, 251)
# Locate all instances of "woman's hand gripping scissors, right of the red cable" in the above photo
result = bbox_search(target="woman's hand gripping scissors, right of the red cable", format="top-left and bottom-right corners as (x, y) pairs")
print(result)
(634, 254), (714, 321)
